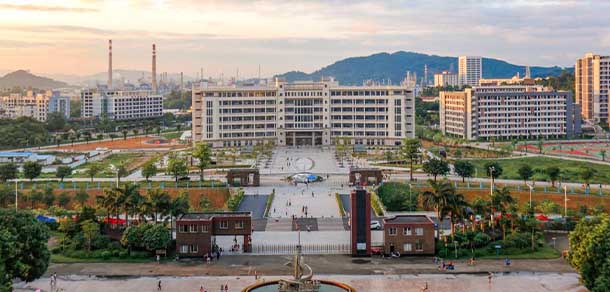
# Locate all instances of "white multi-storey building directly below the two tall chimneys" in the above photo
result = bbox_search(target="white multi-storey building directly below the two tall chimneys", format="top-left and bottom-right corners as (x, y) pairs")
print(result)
(81, 89), (163, 120)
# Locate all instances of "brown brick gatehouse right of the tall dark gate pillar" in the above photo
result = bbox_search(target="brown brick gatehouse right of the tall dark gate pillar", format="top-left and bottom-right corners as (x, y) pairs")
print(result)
(383, 215), (435, 255)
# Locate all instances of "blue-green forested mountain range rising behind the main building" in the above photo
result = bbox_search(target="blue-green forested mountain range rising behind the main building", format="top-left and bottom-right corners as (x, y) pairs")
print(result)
(277, 51), (573, 85)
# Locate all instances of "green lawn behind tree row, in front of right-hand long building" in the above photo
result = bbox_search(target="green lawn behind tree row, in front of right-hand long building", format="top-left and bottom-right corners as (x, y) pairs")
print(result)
(470, 157), (610, 184)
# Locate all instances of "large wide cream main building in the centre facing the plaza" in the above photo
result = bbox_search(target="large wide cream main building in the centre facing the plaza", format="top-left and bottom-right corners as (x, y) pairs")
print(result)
(193, 78), (415, 147)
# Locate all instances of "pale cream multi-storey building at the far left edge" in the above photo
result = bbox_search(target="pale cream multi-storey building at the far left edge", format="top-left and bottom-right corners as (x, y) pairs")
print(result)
(0, 91), (70, 122)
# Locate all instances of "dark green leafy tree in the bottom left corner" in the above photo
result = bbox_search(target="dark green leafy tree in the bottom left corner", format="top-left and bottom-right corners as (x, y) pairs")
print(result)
(0, 209), (51, 291)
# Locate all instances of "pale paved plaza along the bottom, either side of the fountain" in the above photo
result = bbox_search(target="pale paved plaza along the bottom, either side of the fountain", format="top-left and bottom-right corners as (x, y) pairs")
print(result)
(16, 273), (586, 292)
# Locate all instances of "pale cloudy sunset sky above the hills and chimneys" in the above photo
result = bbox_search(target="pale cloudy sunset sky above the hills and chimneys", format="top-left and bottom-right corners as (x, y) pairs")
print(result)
(0, 0), (610, 77)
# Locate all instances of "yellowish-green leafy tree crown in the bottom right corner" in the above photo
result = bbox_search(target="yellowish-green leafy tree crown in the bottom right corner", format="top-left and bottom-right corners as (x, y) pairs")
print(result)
(568, 214), (610, 292)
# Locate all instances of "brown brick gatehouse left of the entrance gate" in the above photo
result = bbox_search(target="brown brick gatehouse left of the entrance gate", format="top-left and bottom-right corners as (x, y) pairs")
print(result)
(176, 212), (252, 257)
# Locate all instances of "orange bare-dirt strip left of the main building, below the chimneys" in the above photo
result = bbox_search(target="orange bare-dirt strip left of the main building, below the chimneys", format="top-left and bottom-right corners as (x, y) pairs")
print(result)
(52, 137), (188, 151)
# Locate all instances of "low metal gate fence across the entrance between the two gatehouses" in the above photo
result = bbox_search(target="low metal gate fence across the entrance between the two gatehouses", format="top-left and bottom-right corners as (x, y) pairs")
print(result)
(252, 243), (351, 255)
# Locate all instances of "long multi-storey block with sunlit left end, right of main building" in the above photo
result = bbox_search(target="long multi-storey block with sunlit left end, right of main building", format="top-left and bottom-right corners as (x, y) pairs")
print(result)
(440, 85), (581, 140)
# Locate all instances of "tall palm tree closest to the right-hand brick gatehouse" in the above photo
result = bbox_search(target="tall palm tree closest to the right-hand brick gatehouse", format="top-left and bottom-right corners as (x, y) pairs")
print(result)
(423, 178), (455, 236)
